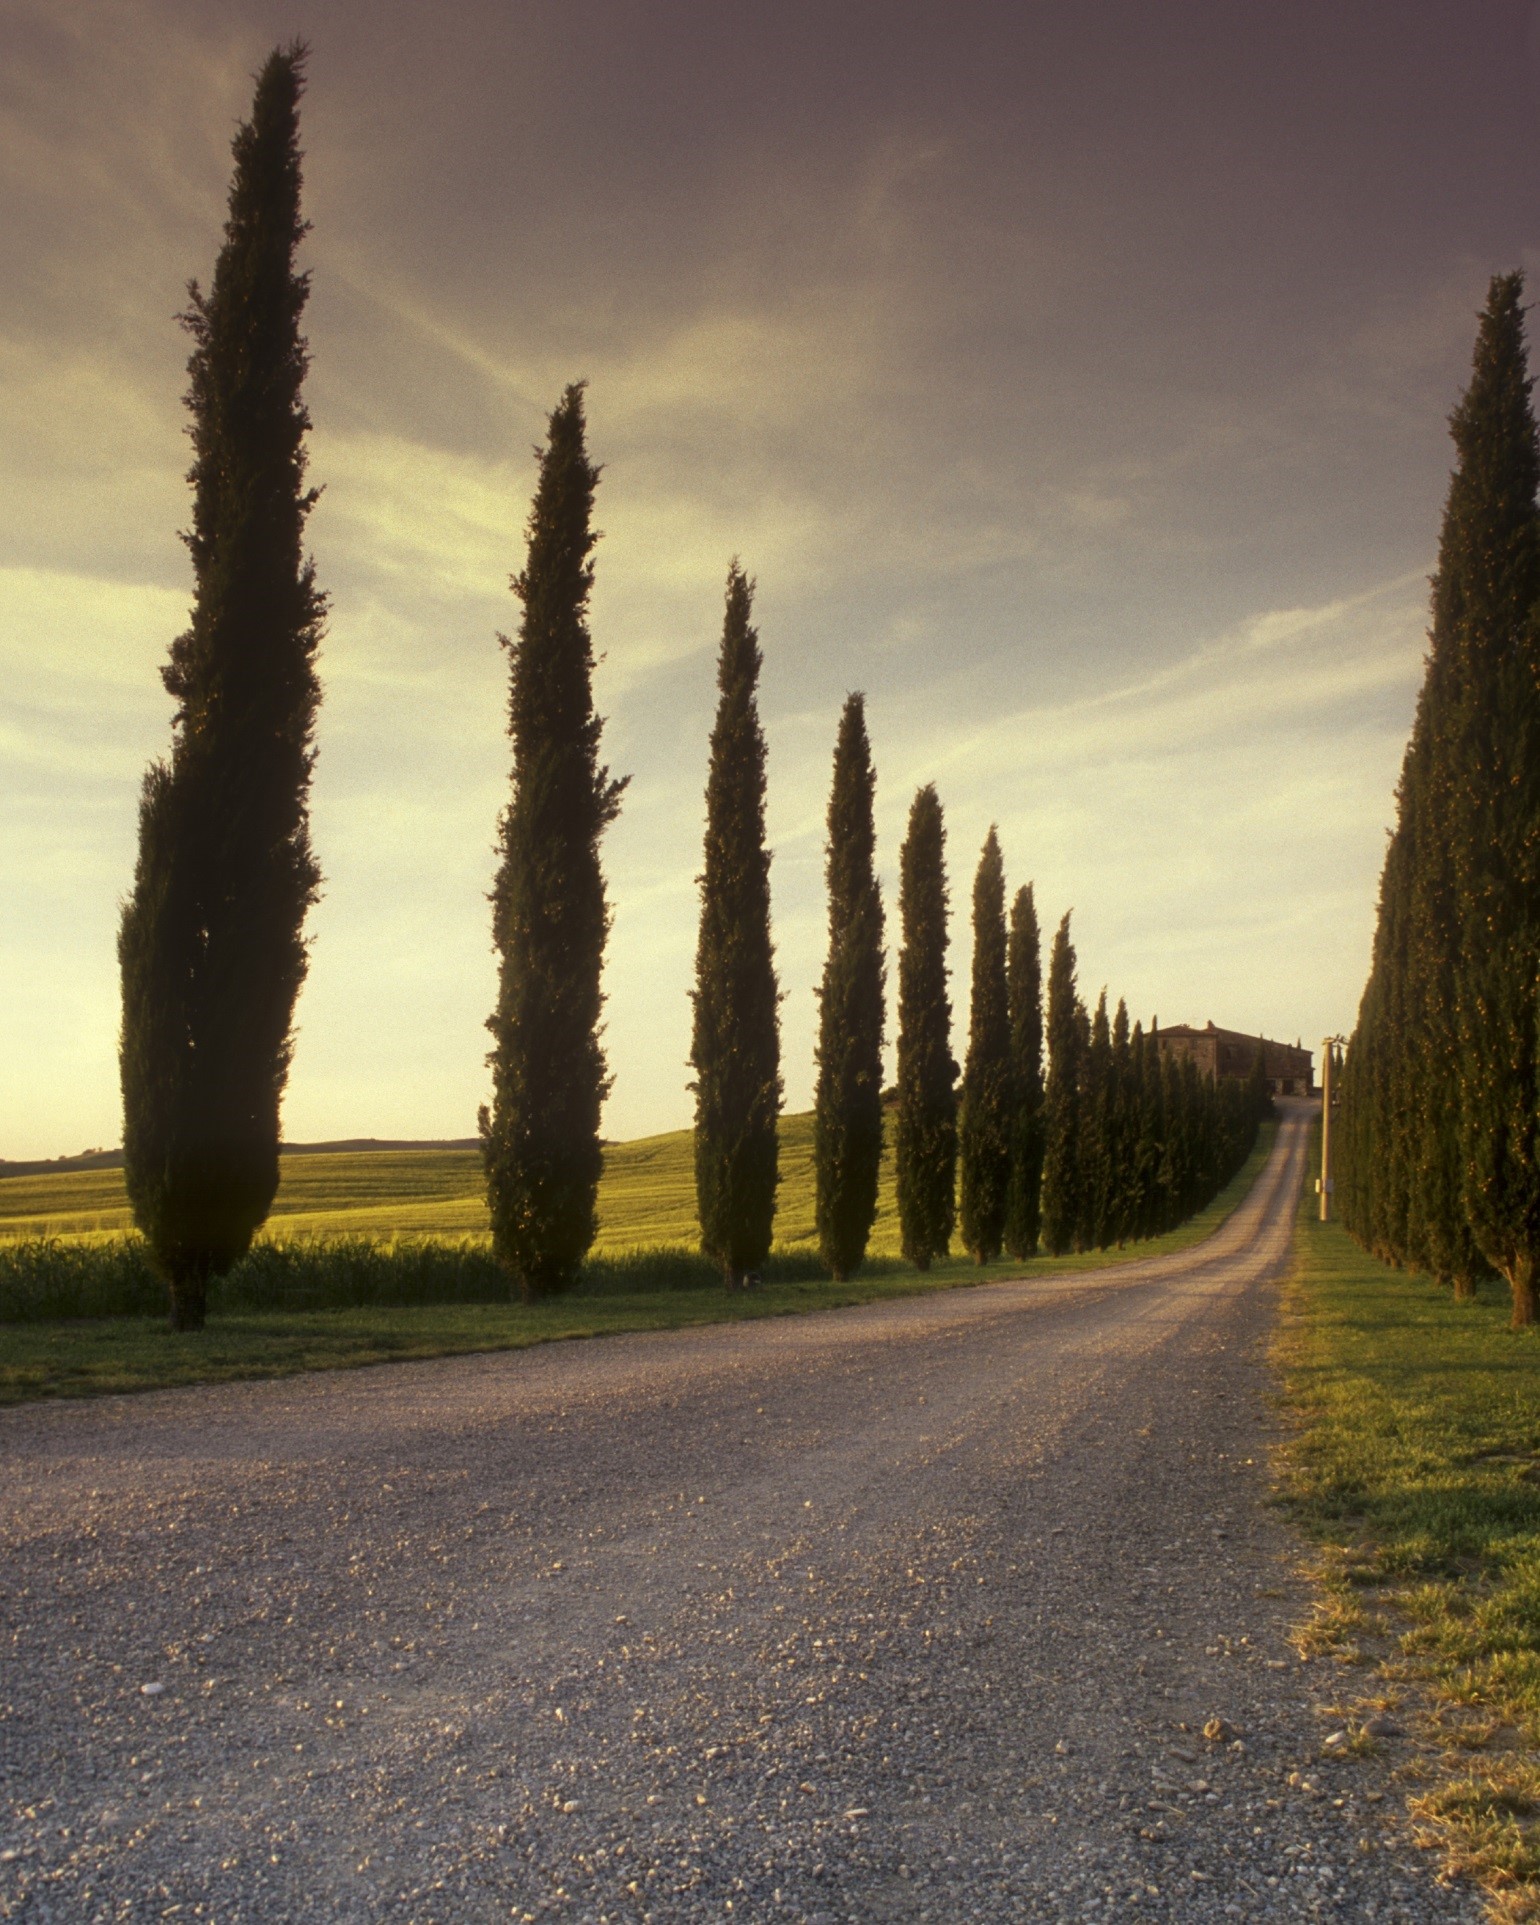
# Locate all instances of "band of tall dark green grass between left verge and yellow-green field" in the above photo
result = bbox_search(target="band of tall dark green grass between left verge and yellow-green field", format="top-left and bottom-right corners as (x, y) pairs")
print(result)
(0, 1236), (854, 1322)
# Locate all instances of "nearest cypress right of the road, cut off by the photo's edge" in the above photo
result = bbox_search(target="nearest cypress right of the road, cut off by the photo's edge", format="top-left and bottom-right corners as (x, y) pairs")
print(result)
(1440, 273), (1540, 1328)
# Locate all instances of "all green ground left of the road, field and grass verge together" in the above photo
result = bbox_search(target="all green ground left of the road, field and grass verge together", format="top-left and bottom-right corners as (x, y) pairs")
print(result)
(0, 1117), (1276, 1405)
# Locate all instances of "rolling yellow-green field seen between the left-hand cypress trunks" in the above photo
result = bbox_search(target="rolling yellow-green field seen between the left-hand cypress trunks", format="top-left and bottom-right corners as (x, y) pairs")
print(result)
(0, 1113), (866, 1257)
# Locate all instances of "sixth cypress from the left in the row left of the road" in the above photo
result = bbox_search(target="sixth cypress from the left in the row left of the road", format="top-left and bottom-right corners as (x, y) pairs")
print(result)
(959, 824), (1016, 1263)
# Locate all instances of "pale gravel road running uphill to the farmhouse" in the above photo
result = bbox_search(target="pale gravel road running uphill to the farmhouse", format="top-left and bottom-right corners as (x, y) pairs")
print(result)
(0, 1111), (1480, 1925)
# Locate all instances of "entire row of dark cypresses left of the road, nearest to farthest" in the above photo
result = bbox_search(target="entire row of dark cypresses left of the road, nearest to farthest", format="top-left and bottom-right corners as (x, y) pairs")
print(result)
(119, 56), (1278, 1328)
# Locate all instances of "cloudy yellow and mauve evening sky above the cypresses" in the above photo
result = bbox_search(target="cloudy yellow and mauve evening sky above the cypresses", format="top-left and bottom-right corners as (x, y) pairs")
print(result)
(0, 0), (1540, 1157)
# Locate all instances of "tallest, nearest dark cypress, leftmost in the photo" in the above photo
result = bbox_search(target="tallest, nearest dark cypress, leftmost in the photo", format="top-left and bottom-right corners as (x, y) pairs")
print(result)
(117, 42), (325, 1330)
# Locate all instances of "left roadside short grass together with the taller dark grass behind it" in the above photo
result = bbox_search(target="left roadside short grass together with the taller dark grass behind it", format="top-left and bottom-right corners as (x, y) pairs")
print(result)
(0, 1124), (1276, 1403)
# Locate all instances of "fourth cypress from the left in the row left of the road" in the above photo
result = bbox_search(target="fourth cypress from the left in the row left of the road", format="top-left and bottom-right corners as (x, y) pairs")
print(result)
(812, 695), (887, 1280)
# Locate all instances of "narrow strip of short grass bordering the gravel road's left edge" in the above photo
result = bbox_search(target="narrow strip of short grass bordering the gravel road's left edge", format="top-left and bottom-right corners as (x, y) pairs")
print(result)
(0, 1124), (1276, 1403)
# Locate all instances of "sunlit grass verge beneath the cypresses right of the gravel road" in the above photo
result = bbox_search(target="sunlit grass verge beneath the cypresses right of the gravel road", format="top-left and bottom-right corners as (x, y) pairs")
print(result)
(1278, 1139), (1540, 1921)
